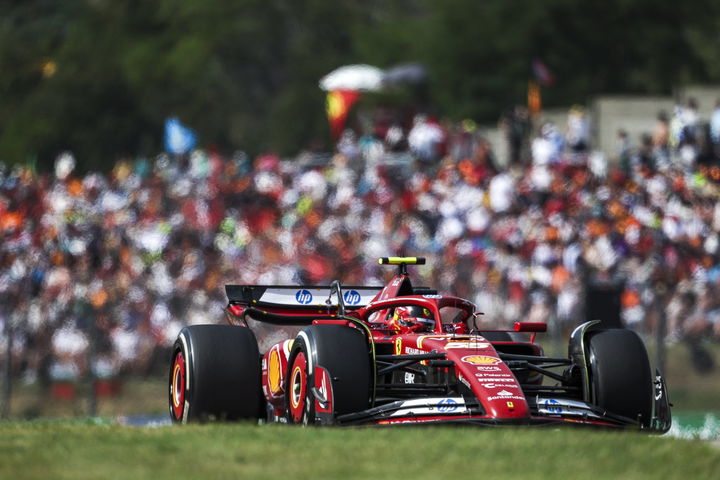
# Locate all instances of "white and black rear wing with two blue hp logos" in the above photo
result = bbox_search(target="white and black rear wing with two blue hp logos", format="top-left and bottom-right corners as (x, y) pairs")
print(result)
(225, 285), (384, 313)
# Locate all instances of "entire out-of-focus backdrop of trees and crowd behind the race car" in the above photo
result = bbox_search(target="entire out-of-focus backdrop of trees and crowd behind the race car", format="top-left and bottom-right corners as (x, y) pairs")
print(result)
(0, 0), (720, 434)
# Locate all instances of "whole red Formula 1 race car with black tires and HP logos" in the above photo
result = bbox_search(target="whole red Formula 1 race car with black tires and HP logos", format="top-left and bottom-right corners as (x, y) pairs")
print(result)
(169, 257), (671, 433)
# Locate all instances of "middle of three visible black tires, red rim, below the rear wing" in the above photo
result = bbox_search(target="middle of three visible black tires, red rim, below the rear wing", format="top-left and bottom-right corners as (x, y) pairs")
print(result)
(285, 325), (371, 425)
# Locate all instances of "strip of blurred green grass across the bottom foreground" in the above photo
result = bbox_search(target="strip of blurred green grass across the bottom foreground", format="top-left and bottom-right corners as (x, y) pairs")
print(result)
(0, 421), (720, 480)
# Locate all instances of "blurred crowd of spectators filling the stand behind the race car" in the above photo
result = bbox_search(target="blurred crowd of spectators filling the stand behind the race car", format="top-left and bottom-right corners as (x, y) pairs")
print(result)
(0, 98), (720, 382)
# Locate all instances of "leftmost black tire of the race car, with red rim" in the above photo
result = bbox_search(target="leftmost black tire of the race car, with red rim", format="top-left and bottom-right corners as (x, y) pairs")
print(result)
(169, 325), (263, 423)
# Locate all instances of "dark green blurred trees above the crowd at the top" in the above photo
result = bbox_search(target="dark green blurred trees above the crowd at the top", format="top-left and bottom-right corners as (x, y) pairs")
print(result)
(0, 0), (720, 170)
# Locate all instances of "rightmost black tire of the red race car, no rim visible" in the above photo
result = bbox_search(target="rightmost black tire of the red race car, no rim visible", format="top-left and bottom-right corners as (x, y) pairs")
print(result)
(587, 328), (653, 426)
